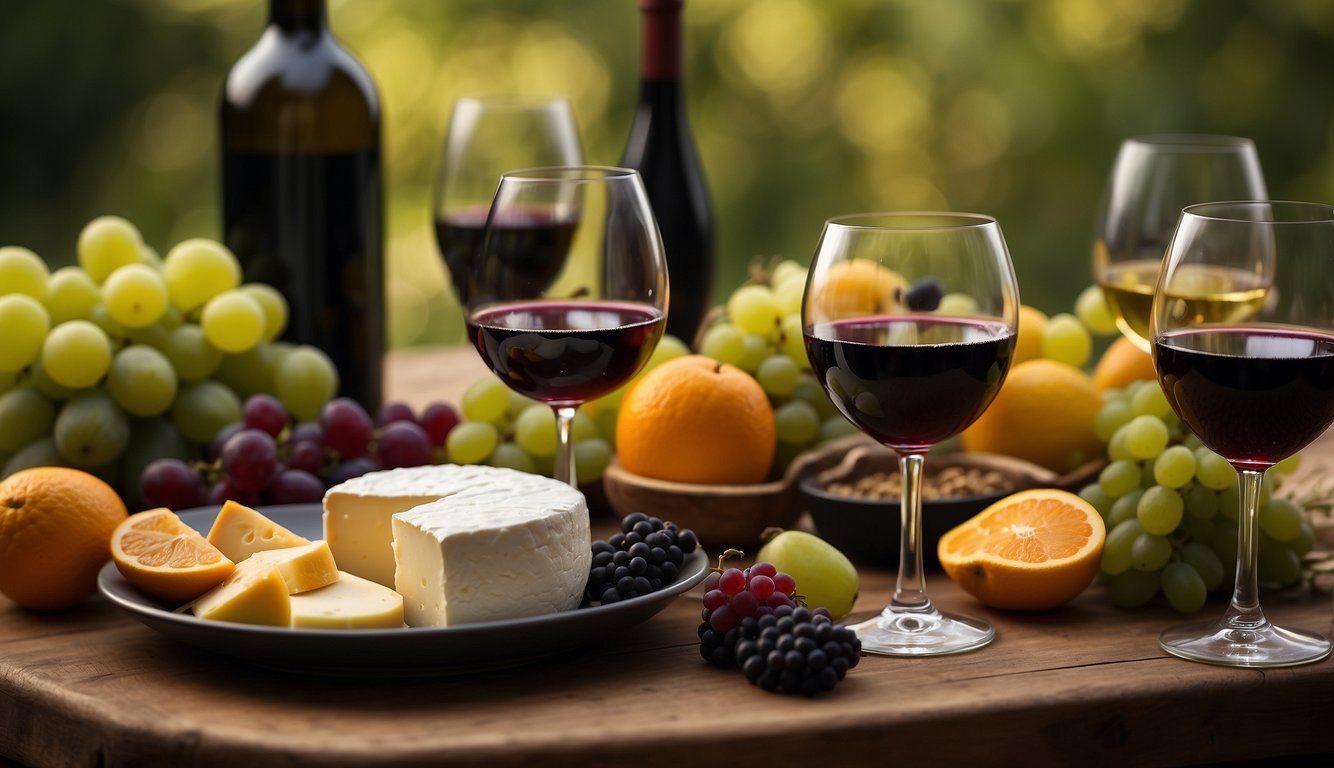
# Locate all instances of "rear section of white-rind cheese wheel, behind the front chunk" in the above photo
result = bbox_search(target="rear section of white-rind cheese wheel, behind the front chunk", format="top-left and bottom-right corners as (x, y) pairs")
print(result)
(324, 464), (523, 588)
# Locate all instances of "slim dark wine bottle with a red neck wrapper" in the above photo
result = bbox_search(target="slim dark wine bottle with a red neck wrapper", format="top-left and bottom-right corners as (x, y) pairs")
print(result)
(622, 0), (714, 343)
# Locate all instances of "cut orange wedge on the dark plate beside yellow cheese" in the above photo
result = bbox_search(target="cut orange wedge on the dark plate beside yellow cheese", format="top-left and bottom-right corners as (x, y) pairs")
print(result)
(111, 509), (236, 603)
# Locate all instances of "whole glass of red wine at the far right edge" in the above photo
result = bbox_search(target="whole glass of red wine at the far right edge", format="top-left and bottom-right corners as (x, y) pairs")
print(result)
(1151, 201), (1334, 667)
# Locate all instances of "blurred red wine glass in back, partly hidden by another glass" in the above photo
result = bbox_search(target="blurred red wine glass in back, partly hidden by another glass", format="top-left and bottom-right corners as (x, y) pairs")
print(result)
(434, 99), (583, 305)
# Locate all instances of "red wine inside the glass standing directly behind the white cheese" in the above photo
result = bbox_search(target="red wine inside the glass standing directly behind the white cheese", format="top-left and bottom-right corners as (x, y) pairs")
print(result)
(468, 301), (666, 407)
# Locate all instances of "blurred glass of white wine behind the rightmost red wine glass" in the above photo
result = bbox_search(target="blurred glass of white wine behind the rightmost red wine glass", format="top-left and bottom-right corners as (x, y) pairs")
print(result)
(1093, 133), (1269, 352)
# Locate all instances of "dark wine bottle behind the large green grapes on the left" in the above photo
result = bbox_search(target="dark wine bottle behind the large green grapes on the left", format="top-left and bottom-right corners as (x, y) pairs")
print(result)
(221, 0), (384, 413)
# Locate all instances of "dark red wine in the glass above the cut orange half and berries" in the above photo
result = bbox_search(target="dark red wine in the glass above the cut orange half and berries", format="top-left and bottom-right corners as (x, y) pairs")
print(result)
(806, 316), (1015, 452)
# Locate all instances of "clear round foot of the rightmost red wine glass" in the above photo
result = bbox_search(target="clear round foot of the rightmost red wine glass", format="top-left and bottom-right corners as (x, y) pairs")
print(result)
(1158, 621), (1330, 667)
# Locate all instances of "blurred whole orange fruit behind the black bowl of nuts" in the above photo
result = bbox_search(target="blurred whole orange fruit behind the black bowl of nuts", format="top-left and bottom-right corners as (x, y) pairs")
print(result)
(963, 359), (1103, 472)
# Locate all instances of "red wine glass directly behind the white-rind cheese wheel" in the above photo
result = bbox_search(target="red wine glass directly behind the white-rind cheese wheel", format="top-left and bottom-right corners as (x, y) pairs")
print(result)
(467, 165), (667, 485)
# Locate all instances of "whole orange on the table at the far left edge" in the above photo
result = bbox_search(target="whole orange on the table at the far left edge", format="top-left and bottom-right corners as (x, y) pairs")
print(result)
(0, 467), (125, 611)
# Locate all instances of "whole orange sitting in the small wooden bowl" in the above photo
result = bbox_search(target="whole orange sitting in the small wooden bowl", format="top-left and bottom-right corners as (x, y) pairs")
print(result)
(616, 355), (778, 485)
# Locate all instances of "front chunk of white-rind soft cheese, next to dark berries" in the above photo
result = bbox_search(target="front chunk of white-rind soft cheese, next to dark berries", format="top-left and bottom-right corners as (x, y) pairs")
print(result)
(392, 468), (592, 627)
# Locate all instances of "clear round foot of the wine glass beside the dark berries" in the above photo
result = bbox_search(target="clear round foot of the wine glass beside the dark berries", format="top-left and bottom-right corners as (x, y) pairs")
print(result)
(852, 605), (996, 656)
